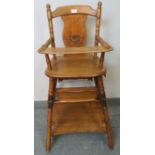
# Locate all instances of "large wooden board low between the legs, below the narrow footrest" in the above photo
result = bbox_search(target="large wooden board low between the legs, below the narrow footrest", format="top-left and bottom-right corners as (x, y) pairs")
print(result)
(53, 102), (105, 135)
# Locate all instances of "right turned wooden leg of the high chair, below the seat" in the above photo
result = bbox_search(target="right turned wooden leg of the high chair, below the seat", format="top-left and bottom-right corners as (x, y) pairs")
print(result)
(98, 77), (113, 149)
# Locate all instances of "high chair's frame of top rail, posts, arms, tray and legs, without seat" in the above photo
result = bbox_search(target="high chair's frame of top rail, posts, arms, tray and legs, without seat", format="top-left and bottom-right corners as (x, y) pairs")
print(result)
(38, 2), (113, 152)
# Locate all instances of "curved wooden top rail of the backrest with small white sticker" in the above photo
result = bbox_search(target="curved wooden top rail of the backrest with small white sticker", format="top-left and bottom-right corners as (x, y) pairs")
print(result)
(52, 5), (96, 18)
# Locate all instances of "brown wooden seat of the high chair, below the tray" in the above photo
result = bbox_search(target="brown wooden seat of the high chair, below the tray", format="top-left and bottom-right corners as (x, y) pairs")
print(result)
(46, 54), (106, 78)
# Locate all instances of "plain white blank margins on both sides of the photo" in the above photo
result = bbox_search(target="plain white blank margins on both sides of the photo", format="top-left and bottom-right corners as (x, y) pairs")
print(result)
(0, 0), (155, 155)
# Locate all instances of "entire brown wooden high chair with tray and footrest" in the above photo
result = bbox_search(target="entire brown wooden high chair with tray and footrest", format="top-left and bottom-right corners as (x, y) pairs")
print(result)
(38, 2), (113, 151)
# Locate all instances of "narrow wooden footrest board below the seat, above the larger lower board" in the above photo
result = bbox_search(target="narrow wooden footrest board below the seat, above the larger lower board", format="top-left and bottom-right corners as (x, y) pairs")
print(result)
(55, 87), (98, 103)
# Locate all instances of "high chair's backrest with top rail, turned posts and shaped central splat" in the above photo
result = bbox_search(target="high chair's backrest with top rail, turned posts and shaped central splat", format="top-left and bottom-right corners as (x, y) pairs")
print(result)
(46, 2), (102, 47)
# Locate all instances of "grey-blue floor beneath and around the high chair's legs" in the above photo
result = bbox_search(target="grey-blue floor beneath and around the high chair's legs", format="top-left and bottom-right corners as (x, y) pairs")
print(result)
(34, 99), (120, 155)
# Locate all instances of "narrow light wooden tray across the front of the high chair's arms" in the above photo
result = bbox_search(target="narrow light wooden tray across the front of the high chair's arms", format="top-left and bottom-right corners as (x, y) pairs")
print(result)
(39, 46), (112, 55)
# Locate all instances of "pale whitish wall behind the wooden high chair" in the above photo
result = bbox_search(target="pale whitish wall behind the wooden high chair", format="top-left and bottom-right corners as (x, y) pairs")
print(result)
(34, 0), (120, 100)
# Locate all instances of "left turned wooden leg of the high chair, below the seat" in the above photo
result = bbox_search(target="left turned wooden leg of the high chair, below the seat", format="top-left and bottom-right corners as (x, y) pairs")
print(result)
(46, 79), (56, 152)
